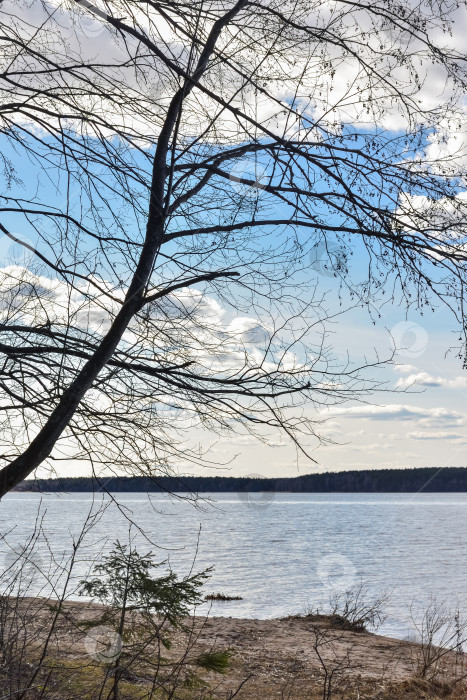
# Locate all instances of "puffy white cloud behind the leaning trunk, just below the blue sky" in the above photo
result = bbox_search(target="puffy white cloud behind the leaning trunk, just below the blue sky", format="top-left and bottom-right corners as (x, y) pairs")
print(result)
(0, 265), (310, 392)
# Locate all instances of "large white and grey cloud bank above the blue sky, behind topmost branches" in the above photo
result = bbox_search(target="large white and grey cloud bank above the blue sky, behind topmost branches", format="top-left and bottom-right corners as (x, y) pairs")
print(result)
(2, 0), (462, 142)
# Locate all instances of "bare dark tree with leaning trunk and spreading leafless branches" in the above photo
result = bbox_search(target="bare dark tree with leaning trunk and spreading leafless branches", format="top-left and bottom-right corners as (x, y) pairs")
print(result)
(0, 0), (466, 495)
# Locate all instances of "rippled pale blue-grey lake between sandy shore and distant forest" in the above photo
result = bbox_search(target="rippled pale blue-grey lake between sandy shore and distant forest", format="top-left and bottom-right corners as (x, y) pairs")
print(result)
(0, 493), (467, 638)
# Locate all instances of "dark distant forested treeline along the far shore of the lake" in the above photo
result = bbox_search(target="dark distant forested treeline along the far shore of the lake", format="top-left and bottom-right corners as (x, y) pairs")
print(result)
(11, 467), (467, 493)
